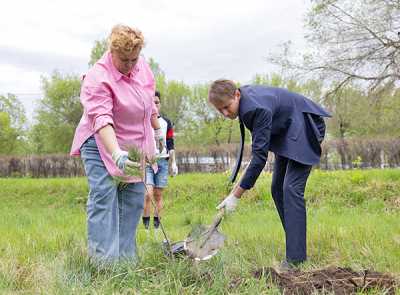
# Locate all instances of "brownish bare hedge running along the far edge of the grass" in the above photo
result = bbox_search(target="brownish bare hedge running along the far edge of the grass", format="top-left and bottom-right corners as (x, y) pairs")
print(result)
(0, 138), (400, 178)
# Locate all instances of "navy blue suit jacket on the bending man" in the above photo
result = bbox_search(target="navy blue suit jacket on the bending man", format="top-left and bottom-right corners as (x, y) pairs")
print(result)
(239, 85), (330, 189)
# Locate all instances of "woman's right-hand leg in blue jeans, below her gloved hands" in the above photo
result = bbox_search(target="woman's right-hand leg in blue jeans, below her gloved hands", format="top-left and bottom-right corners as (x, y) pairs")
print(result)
(118, 182), (145, 259)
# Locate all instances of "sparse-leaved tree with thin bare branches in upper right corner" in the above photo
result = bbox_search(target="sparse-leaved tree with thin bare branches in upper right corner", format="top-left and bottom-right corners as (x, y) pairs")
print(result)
(271, 0), (400, 94)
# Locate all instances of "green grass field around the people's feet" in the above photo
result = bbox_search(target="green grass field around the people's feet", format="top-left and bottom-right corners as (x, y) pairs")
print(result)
(0, 170), (400, 294)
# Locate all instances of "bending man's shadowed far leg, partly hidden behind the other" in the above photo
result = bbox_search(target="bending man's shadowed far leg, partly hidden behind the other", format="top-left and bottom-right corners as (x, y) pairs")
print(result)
(271, 155), (288, 229)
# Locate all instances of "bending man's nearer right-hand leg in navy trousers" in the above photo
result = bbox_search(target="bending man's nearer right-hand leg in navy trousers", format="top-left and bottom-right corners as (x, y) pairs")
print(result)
(283, 160), (312, 263)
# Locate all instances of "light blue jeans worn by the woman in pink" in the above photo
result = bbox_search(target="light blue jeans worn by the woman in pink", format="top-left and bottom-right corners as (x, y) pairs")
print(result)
(80, 136), (145, 262)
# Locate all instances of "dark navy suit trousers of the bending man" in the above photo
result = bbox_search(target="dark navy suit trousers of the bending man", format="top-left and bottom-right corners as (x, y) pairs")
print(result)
(271, 155), (312, 263)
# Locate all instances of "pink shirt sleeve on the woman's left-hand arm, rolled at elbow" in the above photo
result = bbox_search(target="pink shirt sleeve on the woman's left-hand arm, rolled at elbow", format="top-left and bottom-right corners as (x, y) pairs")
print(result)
(81, 86), (114, 133)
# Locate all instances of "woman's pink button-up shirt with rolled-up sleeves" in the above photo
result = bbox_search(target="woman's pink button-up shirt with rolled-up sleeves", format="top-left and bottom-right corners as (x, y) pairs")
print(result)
(71, 51), (158, 182)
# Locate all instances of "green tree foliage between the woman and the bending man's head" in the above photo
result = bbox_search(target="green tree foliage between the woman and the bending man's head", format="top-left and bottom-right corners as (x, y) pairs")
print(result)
(149, 58), (238, 146)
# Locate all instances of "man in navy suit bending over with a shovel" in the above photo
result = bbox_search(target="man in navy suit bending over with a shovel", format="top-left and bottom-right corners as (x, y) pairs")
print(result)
(208, 80), (330, 268)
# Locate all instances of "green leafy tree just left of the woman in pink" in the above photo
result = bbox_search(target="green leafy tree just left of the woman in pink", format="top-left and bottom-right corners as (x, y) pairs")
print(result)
(30, 72), (82, 154)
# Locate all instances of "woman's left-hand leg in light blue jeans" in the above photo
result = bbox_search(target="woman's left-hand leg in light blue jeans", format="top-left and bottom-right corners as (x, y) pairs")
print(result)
(81, 137), (119, 261)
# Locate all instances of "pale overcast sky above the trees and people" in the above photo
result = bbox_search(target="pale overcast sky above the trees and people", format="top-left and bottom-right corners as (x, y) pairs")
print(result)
(0, 0), (310, 120)
